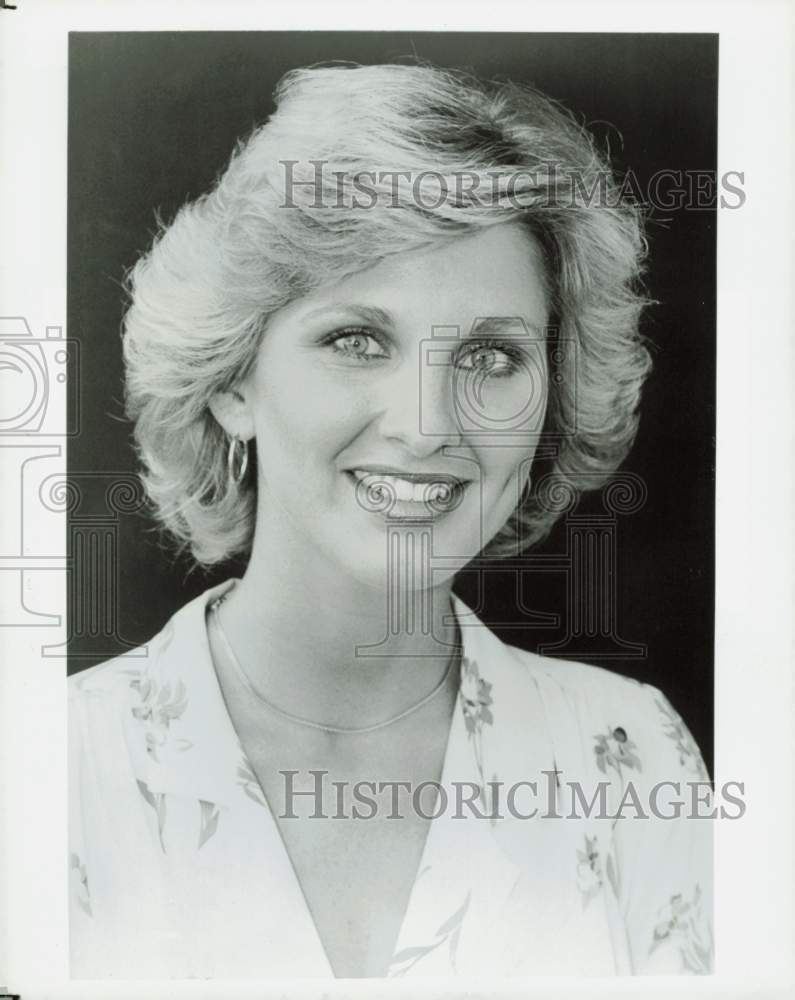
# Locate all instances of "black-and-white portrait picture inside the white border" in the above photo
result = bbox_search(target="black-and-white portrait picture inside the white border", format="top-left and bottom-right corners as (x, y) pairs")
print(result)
(67, 31), (720, 980)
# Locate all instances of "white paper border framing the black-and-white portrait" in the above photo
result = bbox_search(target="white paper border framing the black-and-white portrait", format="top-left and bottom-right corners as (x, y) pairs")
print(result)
(0, 0), (795, 1000)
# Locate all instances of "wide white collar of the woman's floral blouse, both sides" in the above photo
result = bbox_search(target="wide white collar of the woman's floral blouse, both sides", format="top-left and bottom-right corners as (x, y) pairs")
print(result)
(128, 579), (551, 806)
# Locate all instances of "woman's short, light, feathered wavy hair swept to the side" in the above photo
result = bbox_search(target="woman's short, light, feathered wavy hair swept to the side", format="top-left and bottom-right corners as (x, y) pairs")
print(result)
(123, 64), (651, 566)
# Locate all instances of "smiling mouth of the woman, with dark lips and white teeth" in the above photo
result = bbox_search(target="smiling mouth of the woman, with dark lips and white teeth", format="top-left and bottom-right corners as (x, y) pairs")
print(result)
(347, 469), (470, 516)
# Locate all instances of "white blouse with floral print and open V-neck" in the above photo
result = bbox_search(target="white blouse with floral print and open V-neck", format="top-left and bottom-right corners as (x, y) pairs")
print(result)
(69, 581), (712, 979)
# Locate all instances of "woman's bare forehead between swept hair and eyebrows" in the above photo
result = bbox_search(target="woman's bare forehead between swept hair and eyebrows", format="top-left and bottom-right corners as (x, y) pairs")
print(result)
(288, 222), (548, 332)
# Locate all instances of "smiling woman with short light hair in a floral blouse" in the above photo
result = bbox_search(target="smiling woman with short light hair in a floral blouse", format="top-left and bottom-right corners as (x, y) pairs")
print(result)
(71, 65), (711, 978)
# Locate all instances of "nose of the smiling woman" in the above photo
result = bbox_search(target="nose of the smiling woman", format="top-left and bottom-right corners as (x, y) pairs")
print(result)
(379, 357), (462, 458)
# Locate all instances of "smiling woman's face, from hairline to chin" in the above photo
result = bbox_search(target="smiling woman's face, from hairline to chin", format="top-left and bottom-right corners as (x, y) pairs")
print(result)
(237, 223), (548, 587)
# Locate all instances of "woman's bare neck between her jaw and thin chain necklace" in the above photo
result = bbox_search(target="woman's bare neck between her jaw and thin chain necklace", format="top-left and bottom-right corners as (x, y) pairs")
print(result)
(215, 508), (458, 728)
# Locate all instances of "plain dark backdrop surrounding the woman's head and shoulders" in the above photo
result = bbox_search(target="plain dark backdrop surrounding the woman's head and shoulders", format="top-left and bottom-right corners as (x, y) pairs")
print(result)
(68, 32), (718, 770)
